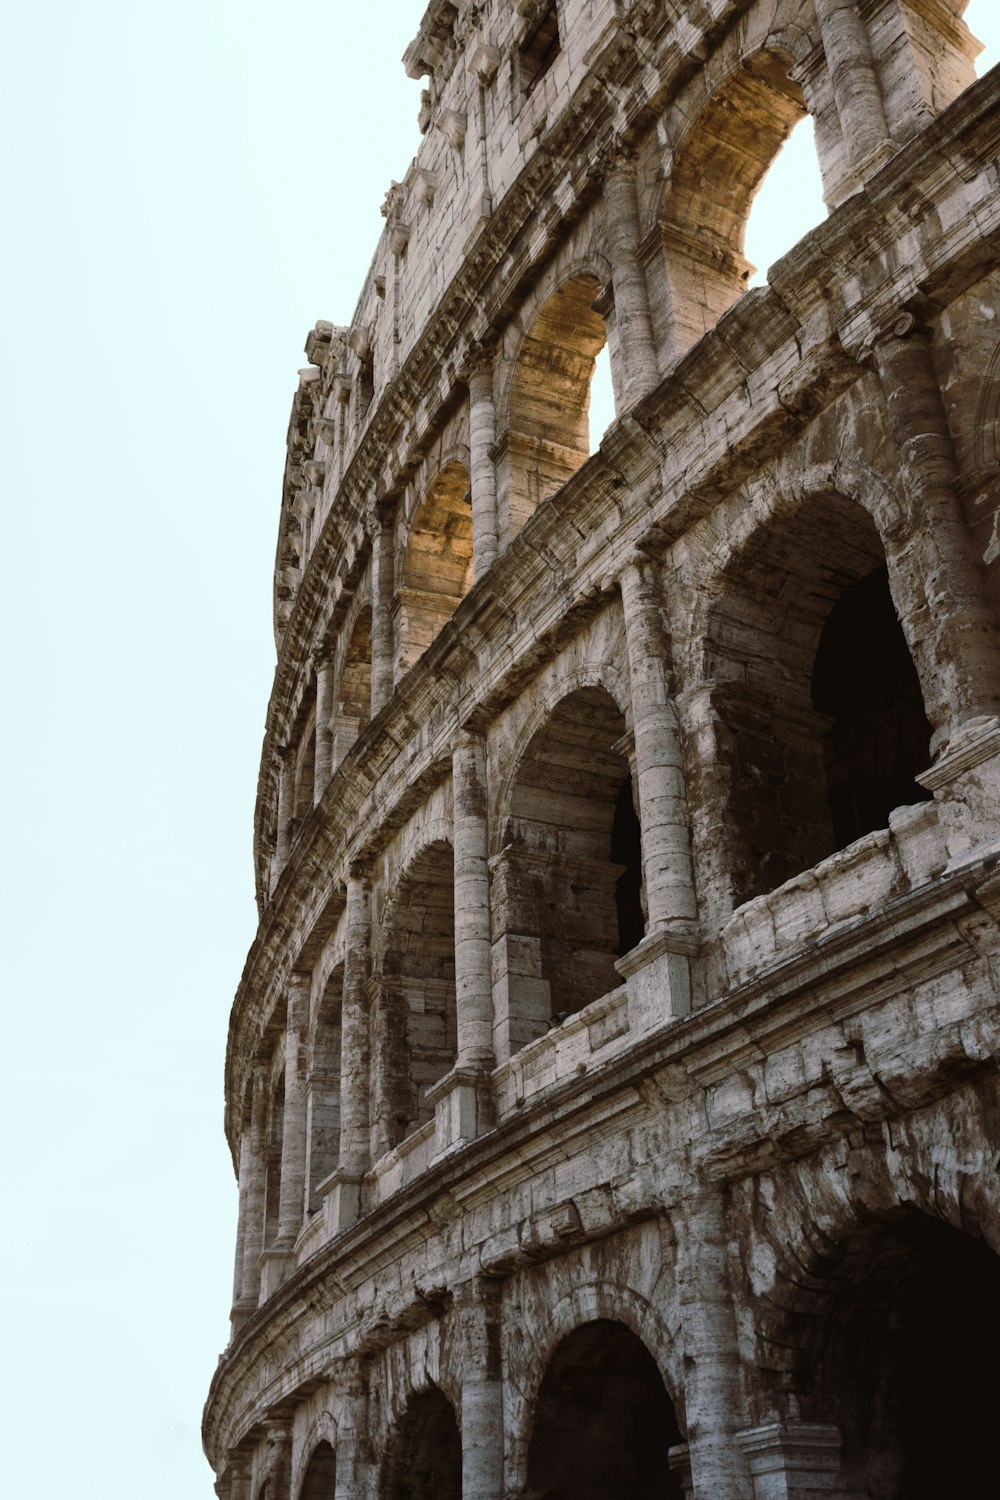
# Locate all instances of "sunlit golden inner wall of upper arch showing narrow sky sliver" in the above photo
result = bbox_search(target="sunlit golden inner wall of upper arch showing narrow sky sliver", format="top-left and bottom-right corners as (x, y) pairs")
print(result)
(498, 275), (607, 542)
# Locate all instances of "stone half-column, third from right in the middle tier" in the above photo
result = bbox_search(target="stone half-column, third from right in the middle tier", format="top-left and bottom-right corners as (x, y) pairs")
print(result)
(451, 732), (493, 1068)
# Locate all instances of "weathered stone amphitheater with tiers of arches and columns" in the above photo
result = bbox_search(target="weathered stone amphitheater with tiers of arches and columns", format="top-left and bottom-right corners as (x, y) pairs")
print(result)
(204, 0), (1000, 1500)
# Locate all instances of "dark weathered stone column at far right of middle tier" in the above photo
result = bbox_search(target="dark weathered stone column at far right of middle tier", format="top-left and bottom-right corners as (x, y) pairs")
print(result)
(874, 314), (1000, 750)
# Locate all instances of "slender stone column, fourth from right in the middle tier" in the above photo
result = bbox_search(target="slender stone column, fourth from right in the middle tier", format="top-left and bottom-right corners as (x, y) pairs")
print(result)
(324, 864), (372, 1235)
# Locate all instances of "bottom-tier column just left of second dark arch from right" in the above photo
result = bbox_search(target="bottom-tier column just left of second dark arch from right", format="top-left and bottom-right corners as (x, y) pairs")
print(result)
(454, 1277), (504, 1500)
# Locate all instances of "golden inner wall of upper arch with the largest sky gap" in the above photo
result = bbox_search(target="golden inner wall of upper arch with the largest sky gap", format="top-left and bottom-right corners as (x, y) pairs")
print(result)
(661, 51), (805, 356)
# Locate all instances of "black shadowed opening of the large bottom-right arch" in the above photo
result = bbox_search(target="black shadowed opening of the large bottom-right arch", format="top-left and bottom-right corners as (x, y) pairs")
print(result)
(796, 1214), (1000, 1500)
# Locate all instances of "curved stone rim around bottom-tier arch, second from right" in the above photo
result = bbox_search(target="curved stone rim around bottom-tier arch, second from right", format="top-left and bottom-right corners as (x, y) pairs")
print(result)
(510, 1281), (684, 1496)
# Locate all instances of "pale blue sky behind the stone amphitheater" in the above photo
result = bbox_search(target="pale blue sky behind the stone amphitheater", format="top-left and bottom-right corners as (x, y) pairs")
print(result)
(0, 0), (1000, 1500)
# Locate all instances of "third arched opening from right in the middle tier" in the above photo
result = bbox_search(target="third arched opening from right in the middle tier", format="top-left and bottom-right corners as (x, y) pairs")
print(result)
(376, 840), (457, 1149)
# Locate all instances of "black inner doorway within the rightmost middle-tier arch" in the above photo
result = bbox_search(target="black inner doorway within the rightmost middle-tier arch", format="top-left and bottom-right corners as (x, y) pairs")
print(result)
(813, 564), (931, 848)
